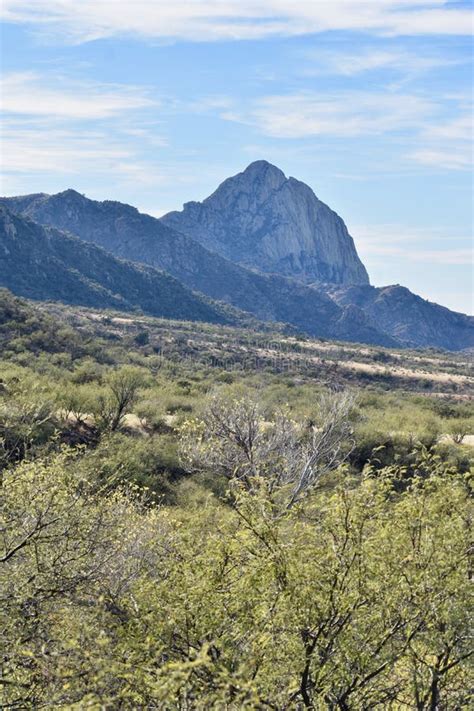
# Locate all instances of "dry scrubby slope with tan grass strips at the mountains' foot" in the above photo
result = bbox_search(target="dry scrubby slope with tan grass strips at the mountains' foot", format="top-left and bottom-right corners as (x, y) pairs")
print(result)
(47, 304), (474, 399)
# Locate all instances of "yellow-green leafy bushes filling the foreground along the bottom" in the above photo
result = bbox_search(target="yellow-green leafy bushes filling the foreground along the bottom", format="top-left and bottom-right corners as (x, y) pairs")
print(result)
(0, 453), (472, 710)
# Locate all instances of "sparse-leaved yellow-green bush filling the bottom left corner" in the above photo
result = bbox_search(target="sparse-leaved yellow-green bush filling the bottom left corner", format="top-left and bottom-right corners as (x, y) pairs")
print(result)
(0, 452), (160, 708)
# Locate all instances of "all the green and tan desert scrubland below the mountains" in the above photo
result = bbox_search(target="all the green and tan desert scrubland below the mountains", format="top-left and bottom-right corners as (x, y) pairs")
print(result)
(0, 292), (474, 711)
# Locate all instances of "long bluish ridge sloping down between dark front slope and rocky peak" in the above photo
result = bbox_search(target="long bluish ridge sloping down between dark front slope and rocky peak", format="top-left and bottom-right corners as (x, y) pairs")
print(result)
(0, 190), (400, 346)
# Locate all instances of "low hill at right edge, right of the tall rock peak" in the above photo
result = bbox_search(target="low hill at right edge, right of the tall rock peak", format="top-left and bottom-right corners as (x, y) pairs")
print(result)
(324, 284), (474, 350)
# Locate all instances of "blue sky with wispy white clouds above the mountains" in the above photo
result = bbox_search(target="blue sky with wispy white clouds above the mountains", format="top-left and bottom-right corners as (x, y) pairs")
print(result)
(0, 0), (474, 313)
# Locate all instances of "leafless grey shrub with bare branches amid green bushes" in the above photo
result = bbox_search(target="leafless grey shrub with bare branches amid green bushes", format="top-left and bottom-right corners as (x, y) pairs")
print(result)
(180, 392), (354, 506)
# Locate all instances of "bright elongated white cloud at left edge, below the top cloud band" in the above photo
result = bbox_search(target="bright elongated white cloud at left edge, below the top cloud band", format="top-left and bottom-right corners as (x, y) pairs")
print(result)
(1, 72), (156, 120)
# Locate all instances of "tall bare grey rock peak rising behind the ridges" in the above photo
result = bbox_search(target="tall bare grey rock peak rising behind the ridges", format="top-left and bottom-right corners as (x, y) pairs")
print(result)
(162, 160), (369, 284)
